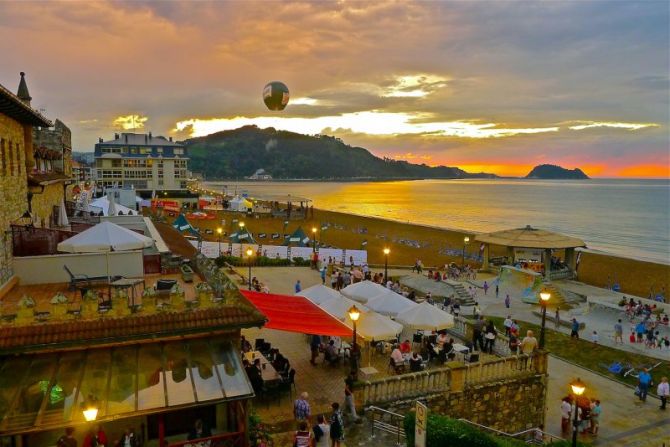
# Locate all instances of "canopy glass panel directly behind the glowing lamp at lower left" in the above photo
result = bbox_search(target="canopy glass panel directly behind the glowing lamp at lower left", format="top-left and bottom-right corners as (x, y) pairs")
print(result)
(72, 349), (111, 421)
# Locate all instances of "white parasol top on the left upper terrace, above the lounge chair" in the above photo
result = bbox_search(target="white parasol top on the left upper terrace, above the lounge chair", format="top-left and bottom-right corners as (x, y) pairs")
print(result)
(57, 222), (154, 253)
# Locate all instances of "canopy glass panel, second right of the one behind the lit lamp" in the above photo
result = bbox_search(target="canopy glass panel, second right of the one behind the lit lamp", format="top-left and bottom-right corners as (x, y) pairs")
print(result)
(137, 344), (165, 410)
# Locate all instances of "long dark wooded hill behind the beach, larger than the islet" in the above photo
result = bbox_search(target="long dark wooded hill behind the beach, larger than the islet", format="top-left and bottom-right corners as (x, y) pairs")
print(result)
(184, 126), (496, 180)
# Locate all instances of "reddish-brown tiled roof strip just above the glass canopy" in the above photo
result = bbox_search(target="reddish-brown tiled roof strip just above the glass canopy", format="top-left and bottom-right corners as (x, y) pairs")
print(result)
(0, 306), (265, 354)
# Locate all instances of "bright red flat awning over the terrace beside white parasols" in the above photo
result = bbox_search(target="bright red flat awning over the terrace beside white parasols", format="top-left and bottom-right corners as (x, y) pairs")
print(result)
(240, 290), (351, 337)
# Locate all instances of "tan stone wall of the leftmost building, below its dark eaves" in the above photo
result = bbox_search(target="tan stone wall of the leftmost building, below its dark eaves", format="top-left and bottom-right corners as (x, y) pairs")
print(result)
(0, 114), (28, 287)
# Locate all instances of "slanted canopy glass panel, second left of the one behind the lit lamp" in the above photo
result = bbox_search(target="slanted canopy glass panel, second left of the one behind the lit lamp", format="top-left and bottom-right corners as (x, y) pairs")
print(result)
(7, 355), (57, 430)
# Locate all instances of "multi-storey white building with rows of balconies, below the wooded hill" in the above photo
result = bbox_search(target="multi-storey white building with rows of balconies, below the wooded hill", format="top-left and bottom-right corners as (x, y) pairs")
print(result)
(94, 132), (190, 198)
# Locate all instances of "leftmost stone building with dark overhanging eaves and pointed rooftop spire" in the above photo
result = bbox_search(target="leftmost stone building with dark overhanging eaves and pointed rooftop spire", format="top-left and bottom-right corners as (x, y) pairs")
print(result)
(0, 73), (52, 296)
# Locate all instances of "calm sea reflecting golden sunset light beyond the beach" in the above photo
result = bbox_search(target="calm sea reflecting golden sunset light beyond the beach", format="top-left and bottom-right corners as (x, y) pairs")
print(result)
(203, 179), (670, 264)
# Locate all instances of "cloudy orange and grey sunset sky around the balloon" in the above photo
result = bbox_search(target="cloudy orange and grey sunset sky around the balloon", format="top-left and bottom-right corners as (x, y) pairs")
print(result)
(0, 0), (670, 178)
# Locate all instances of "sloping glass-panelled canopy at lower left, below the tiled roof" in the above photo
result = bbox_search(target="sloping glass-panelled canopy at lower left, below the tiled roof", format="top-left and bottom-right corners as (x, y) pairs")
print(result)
(0, 342), (253, 436)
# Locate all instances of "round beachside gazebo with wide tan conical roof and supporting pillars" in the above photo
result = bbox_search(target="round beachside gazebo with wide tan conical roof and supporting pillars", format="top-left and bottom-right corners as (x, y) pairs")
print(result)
(475, 225), (586, 278)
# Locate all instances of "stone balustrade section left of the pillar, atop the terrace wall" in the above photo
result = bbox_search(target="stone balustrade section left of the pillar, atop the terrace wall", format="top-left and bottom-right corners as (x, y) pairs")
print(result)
(363, 368), (451, 405)
